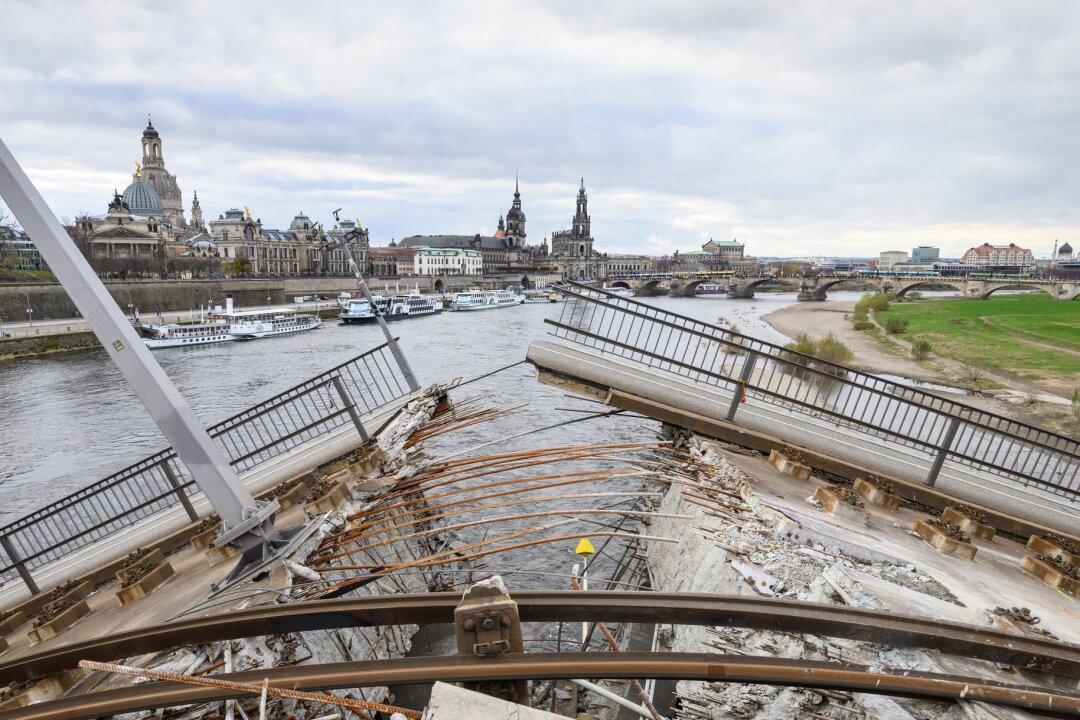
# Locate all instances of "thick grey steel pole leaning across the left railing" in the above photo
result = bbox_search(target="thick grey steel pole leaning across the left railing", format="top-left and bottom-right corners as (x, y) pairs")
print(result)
(0, 140), (276, 538)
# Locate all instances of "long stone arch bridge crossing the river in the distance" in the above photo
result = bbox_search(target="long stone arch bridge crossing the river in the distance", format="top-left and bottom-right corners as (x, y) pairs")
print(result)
(608, 274), (1080, 302)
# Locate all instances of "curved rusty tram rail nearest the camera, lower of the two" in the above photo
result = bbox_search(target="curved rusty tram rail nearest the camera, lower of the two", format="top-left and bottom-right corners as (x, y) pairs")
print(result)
(8, 651), (1080, 720)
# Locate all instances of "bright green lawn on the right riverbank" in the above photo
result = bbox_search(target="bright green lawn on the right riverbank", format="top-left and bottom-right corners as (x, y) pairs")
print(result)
(875, 294), (1080, 378)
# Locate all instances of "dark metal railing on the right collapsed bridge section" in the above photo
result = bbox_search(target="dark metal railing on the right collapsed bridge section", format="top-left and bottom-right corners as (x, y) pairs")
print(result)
(546, 283), (1080, 501)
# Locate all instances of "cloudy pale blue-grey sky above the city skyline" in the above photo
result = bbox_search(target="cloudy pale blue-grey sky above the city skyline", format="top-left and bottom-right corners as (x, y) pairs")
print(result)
(0, 0), (1080, 257)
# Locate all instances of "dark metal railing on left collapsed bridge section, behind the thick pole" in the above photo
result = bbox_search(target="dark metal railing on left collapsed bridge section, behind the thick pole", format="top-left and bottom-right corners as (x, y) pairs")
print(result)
(0, 343), (410, 593)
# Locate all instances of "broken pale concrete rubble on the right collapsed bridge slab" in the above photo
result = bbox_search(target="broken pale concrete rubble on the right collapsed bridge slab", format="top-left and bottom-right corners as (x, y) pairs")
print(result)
(639, 431), (1059, 720)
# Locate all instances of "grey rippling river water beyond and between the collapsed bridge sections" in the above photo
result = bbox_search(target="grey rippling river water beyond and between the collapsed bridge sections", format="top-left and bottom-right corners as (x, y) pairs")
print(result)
(0, 293), (820, 522)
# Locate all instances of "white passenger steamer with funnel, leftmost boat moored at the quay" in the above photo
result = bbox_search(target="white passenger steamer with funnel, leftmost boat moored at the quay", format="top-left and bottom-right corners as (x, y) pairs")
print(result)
(140, 296), (320, 350)
